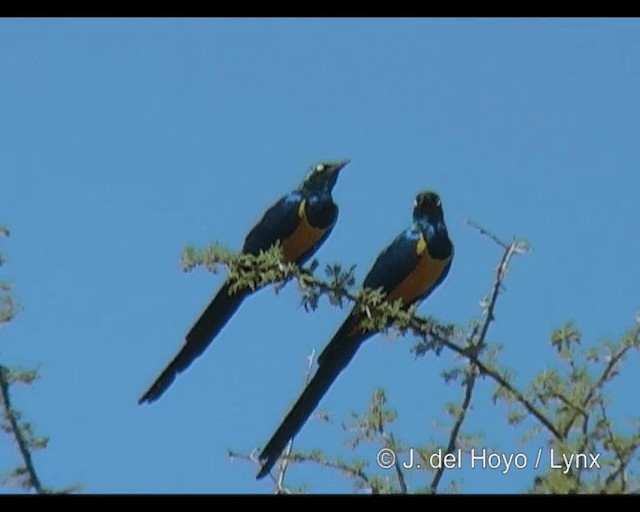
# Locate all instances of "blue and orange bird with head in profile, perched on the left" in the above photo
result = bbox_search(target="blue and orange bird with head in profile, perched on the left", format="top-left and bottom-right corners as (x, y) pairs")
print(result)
(138, 160), (349, 404)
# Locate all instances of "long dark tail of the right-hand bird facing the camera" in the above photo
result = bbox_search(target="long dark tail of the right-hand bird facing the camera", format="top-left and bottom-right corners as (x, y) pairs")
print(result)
(256, 317), (368, 479)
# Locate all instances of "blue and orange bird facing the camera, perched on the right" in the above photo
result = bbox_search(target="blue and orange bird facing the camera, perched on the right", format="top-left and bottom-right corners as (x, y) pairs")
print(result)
(257, 191), (453, 478)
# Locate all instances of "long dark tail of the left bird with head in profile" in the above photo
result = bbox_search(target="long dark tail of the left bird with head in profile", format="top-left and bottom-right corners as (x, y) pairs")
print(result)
(138, 283), (250, 404)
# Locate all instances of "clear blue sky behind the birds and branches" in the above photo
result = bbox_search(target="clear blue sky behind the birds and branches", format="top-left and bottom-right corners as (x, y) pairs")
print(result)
(0, 19), (640, 493)
